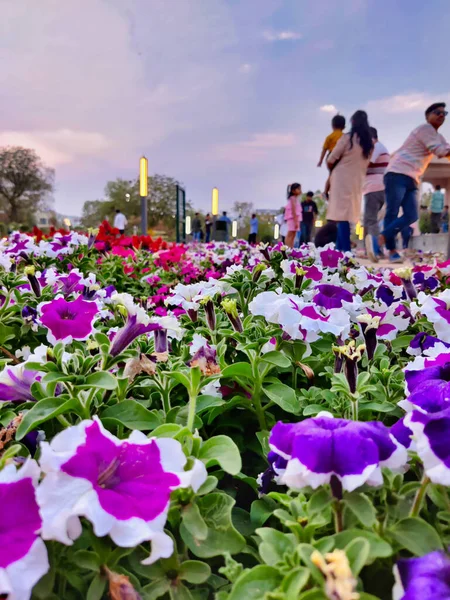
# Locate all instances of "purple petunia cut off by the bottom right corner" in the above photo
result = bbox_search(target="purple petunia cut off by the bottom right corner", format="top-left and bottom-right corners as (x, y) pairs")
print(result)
(392, 551), (450, 600)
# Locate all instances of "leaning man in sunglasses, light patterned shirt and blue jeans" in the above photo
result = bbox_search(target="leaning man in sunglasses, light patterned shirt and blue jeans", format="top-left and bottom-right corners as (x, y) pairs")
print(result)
(379, 102), (450, 263)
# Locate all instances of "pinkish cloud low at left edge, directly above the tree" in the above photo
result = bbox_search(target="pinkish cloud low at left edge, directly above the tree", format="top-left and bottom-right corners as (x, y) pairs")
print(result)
(0, 129), (111, 167)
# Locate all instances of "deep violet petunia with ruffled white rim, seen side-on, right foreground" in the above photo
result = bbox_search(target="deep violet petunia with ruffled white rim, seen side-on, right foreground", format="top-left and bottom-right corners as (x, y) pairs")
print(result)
(269, 416), (407, 491)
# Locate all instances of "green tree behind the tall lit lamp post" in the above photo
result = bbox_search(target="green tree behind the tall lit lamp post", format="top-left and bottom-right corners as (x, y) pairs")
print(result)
(82, 175), (190, 232)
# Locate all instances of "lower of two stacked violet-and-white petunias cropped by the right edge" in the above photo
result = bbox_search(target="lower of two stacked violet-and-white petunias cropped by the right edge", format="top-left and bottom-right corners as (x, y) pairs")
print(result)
(405, 408), (450, 486)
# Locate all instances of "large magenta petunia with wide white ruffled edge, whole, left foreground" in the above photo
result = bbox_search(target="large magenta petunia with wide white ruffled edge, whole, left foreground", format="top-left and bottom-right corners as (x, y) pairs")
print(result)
(37, 418), (207, 564)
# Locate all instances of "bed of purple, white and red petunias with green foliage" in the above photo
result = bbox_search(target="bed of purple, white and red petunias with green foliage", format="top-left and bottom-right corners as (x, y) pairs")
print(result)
(0, 231), (450, 600)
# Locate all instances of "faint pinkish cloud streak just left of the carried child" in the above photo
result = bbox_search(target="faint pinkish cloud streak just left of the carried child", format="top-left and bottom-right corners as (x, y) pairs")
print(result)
(213, 132), (296, 163)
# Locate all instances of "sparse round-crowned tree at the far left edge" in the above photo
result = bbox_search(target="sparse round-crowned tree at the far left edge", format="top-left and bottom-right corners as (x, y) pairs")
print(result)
(0, 146), (54, 223)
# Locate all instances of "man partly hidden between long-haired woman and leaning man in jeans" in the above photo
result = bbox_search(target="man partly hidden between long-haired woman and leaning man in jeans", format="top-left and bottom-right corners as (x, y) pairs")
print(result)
(363, 127), (390, 262)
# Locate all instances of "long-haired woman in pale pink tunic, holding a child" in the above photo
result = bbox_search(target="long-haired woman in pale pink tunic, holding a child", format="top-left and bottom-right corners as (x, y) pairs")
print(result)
(327, 110), (373, 252)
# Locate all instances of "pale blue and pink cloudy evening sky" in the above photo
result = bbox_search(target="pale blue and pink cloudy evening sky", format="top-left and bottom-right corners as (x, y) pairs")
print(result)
(0, 0), (450, 215)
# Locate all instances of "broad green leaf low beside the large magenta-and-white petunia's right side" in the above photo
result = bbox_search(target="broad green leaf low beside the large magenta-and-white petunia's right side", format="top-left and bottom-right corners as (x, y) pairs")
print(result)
(180, 492), (245, 558)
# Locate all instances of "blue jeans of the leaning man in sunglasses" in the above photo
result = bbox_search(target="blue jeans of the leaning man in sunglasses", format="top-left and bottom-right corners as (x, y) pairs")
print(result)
(383, 173), (419, 250)
